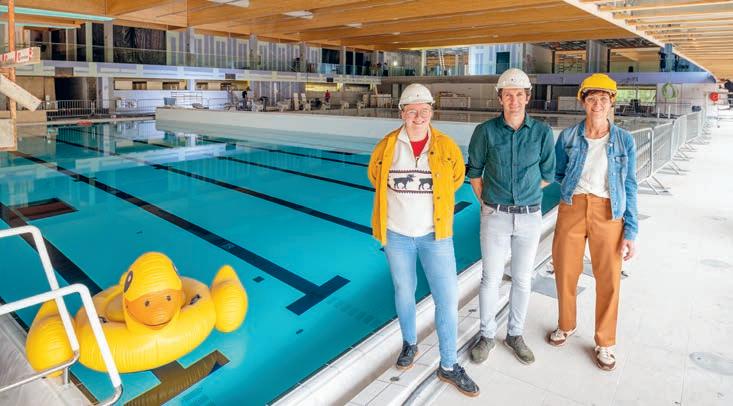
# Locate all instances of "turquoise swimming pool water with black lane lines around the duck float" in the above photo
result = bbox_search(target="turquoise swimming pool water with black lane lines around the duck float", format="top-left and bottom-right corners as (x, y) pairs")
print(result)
(0, 122), (557, 405)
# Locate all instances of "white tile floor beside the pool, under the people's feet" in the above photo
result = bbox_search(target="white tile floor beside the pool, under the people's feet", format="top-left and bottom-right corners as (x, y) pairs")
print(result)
(433, 115), (733, 406)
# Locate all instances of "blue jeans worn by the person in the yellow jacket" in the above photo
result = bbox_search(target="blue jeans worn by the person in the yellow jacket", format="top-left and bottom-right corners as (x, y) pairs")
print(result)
(384, 230), (458, 368)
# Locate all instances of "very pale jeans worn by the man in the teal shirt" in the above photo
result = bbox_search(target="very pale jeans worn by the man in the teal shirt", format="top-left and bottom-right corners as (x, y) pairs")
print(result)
(479, 203), (542, 338)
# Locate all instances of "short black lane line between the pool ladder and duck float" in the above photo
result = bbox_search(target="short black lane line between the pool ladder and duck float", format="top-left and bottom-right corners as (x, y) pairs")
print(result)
(0, 202), (102, 296)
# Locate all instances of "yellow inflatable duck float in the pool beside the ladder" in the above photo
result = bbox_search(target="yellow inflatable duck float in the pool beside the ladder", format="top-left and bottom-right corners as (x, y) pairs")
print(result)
(26, 252), (247, 372)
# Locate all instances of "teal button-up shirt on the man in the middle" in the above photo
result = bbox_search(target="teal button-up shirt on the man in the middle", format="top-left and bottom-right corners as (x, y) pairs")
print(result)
(467, 114), (555, 206)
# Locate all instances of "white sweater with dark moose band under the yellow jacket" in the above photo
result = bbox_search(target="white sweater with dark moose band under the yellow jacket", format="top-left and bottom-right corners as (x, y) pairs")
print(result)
(387, 126), (435, 237)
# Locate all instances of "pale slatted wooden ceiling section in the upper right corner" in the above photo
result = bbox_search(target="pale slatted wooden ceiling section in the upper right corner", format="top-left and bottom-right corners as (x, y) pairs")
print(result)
(576, 0), (733, 78)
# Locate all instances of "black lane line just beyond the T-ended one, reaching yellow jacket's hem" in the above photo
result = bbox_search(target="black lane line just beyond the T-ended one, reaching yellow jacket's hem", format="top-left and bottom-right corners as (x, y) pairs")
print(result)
(56, 138), (372, 235)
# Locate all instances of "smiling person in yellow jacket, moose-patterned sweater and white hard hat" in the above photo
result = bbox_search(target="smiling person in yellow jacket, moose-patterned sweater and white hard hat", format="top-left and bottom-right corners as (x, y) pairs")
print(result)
(369, 84), (479, 396)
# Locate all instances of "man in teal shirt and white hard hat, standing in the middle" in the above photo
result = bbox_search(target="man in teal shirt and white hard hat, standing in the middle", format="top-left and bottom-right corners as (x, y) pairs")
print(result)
(467, 69), (555, 364)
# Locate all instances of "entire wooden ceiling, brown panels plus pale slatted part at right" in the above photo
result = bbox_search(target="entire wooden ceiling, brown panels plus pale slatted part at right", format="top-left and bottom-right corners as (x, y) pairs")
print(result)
(3, 0), (733, 77)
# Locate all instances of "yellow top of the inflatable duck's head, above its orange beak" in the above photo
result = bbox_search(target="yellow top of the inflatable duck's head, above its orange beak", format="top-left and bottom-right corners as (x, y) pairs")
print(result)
(120, 252), (183, 301)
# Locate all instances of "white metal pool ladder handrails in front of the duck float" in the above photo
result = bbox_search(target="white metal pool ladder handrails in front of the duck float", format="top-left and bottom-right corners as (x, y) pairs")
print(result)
(0, 226), (122, 405)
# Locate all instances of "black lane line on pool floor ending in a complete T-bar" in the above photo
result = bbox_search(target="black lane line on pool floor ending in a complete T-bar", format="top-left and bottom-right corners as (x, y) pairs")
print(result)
(10, 151), (349, 315)
